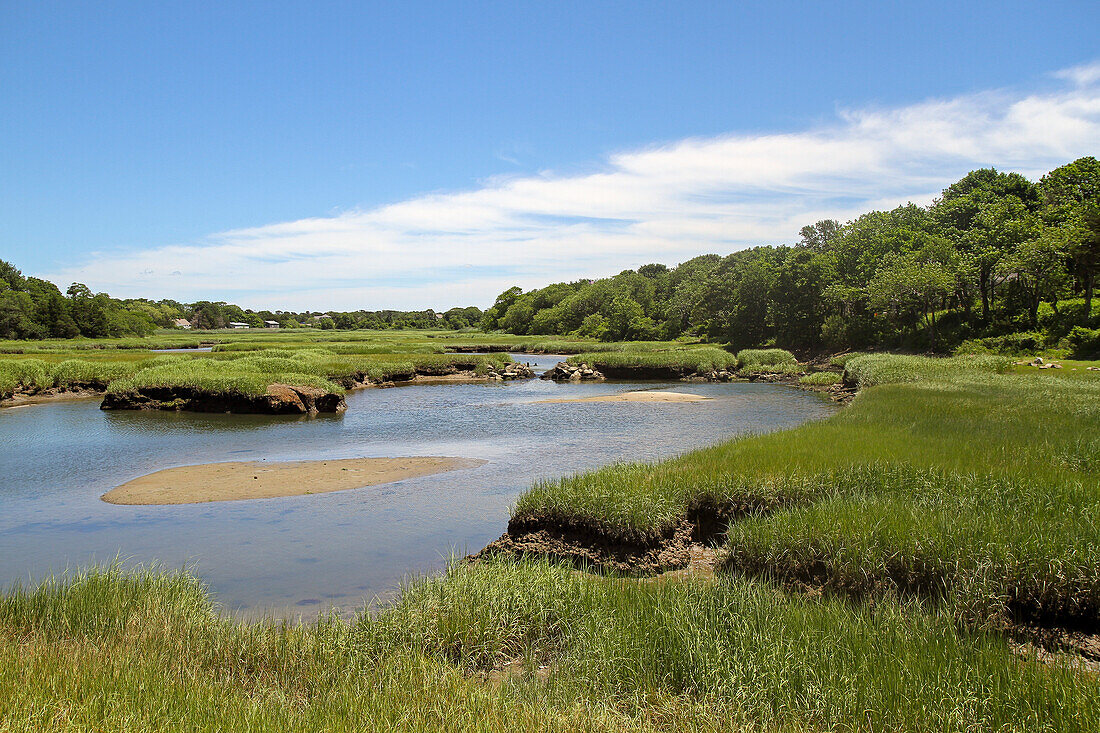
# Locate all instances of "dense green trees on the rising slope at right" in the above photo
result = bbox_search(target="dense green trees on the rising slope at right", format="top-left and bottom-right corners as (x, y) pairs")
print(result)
(481, 156), (1100, 350)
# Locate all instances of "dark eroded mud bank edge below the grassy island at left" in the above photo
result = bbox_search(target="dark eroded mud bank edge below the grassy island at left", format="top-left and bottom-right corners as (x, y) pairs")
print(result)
(99, 384), (348, 415)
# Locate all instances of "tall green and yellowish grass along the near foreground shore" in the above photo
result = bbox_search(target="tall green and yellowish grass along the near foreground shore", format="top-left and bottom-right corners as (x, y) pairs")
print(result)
(0, 561), (1100, 732)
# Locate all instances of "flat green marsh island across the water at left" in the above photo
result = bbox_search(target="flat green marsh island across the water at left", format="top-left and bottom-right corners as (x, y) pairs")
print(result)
(0, 331), (512, 413)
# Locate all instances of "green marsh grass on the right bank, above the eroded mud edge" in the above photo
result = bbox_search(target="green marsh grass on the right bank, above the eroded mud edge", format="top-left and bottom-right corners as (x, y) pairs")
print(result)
(514, 357), (1100, 624)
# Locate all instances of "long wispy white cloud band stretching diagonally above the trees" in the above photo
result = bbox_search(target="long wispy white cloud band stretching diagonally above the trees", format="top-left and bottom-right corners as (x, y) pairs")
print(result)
(45, 63), (1100, 308)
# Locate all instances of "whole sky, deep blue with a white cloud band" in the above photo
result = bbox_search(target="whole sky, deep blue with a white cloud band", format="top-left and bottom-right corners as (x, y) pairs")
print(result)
(0, 0), (1100, 308)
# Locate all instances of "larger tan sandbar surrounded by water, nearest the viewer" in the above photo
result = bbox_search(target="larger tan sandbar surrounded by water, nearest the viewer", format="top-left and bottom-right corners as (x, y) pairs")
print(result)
(100, 456), (485, 504)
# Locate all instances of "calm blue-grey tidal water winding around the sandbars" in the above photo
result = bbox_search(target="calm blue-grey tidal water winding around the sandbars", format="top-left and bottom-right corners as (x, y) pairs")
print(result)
(0, 354), (834, 616)
